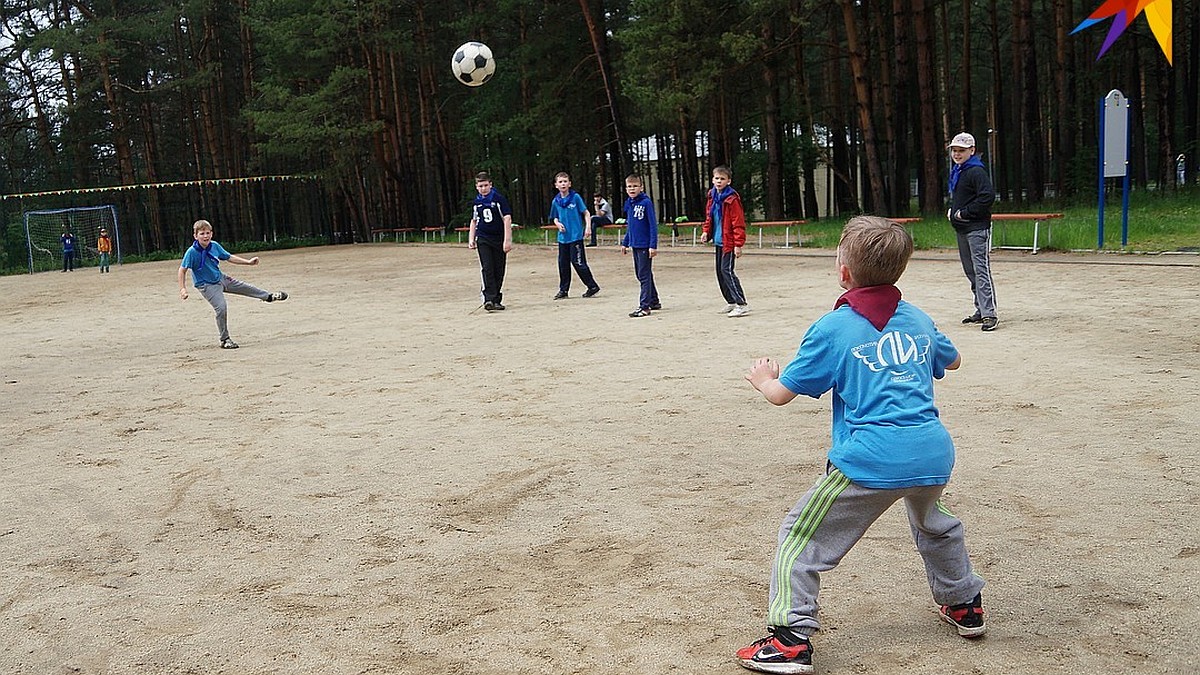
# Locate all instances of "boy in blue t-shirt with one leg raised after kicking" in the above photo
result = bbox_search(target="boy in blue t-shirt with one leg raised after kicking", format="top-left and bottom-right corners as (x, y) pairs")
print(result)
(179, 220), (288, 350)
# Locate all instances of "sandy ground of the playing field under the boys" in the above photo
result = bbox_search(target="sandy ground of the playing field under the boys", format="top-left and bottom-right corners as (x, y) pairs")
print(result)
(0, 239), (1200, 675)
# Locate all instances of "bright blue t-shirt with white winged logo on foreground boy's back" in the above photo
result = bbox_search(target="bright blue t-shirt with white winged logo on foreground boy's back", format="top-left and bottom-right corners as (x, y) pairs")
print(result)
(779, 300), (959, 489)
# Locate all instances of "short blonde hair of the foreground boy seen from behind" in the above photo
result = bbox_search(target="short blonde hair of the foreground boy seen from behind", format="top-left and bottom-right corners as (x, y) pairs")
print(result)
(838, 216), (912, 286)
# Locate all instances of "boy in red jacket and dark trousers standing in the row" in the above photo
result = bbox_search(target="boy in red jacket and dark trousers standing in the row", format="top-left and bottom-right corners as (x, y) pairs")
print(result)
(700, 166), (750, 318)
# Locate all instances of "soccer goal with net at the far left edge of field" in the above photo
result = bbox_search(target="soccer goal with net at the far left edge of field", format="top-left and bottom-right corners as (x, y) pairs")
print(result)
(25, 204), (121, 274)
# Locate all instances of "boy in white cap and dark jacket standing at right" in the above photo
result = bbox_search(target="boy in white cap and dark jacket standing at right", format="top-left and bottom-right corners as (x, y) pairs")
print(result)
(946, 132), (1000, 331)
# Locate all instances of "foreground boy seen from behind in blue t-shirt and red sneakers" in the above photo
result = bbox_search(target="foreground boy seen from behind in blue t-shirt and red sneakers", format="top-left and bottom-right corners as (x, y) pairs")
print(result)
(737, 216), (986, 673)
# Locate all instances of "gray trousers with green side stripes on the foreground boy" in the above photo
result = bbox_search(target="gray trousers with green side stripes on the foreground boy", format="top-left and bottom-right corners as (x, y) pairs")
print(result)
(767, 466), (984, 635)
